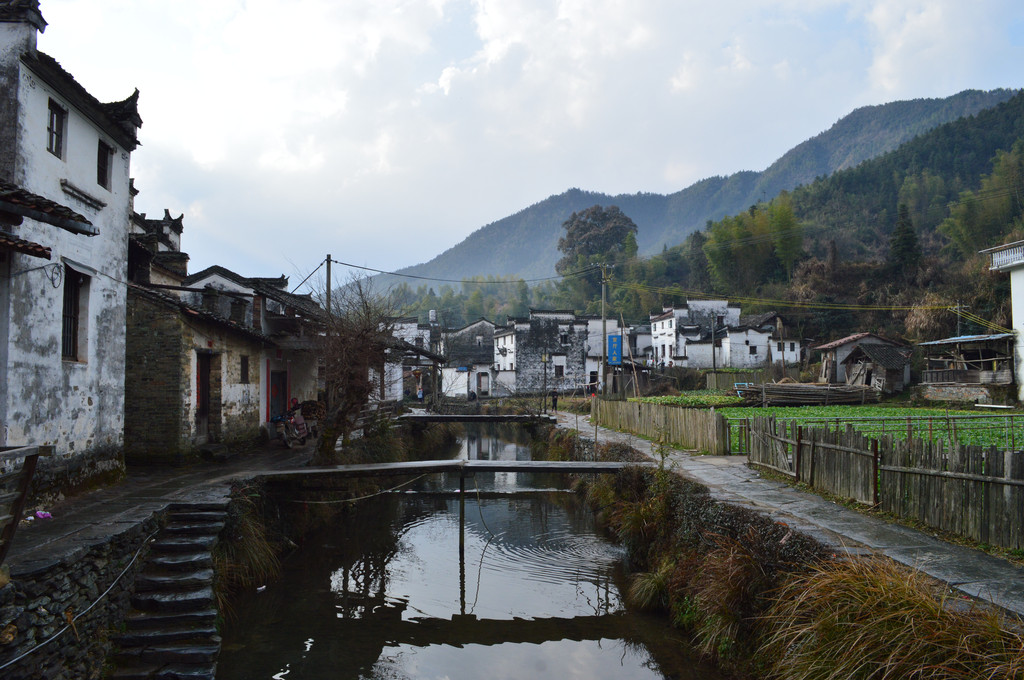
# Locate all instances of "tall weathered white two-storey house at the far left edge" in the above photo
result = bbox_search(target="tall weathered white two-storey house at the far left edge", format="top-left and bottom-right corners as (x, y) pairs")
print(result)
(0, 2), (142, 493)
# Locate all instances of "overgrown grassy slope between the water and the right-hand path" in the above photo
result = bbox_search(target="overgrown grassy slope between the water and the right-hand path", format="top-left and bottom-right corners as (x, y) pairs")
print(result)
(565, 446), (1024, 680)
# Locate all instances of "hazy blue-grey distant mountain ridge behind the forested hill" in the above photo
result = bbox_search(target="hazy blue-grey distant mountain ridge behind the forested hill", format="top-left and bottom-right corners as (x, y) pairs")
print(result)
(385, 89), (1017, 279)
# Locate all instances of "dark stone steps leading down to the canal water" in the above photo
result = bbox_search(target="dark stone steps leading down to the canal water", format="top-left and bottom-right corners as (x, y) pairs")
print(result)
(110, 503), (227, 680)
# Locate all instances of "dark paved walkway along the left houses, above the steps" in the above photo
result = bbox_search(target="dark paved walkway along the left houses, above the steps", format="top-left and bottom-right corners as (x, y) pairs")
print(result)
(6, 441), (312, 579)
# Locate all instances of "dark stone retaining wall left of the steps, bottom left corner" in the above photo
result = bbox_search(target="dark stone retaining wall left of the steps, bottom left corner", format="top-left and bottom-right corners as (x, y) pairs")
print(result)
(0, 515), (160, 680)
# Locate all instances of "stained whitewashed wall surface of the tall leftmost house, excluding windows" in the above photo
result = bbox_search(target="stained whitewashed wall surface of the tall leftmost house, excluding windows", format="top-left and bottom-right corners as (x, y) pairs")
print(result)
(0, 53), (130, 457)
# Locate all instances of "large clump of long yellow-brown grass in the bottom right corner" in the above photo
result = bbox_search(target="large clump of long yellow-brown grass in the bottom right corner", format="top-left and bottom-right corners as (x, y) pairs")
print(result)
(761, 558), (1024, 680)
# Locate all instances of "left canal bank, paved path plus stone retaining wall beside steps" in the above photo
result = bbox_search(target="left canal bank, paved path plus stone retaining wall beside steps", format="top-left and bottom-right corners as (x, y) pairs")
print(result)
(0, 442), (312, 680)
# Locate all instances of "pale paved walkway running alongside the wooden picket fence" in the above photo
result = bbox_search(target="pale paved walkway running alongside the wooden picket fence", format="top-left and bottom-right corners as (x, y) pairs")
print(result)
(558, 412), (1024, 620)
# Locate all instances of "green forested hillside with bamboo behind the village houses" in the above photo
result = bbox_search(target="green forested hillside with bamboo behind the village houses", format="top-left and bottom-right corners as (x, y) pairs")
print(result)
(396, 94), (1024, 340)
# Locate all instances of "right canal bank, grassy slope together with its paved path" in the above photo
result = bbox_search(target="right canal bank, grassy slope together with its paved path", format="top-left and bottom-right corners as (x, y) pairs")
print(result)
(560, 415), (1024, 680)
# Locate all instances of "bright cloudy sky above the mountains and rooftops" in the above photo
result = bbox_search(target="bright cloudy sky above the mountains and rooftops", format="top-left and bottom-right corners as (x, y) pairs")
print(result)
(39, 0), (1024, 285)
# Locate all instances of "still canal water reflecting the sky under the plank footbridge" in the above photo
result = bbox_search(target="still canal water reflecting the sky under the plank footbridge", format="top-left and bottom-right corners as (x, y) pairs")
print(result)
(217, 429), (722, 680)
